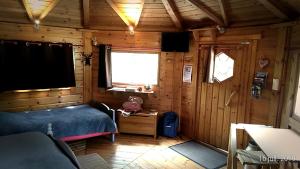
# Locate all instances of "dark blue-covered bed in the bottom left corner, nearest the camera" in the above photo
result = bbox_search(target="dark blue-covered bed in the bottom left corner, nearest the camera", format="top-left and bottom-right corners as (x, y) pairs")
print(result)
(0, 132), (80, 169)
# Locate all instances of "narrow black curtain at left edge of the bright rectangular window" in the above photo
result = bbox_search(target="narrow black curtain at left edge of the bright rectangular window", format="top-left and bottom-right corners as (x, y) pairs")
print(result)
(98, 44), (112, 89)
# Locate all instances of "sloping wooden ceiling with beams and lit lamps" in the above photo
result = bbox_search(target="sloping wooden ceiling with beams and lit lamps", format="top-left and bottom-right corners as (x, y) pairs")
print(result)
(0, 0), (300, 31)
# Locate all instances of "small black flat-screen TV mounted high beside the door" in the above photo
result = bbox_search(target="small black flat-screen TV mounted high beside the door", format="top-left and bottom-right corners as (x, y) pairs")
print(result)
(161, 32), (189, 52)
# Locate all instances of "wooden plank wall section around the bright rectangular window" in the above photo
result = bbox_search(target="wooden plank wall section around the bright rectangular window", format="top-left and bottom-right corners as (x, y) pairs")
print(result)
(92, 31), (197, 121)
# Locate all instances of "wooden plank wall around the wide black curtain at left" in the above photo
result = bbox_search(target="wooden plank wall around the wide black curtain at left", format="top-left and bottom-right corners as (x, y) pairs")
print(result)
(0, 22), (83, 111)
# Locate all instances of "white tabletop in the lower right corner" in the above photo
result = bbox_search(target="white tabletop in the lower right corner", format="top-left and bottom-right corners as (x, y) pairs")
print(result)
(244, 125), (300, 161)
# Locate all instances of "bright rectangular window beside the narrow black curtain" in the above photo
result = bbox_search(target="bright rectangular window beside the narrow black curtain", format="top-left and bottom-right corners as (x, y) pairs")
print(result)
(111, 52), (158, 85)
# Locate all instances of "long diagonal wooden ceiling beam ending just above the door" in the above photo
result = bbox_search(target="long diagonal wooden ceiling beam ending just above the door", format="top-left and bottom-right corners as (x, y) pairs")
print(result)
(187, 0), (225, 26)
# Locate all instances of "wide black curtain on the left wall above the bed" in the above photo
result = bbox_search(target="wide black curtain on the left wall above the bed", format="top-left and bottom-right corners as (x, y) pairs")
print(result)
(0, 40), (75, 92)
